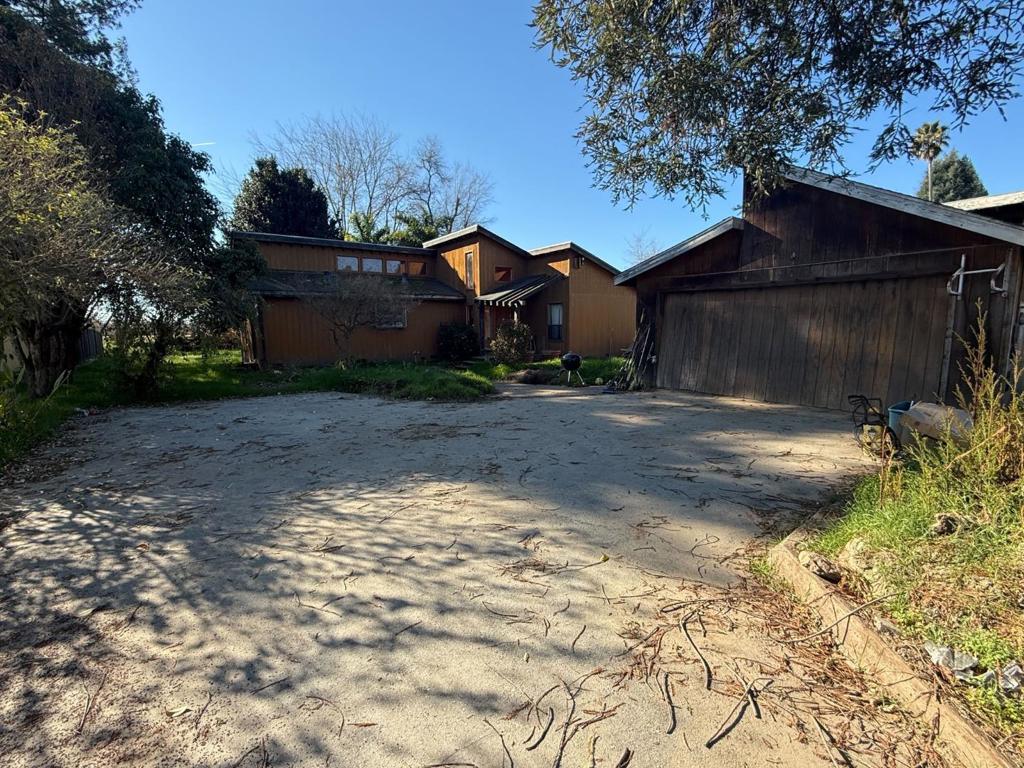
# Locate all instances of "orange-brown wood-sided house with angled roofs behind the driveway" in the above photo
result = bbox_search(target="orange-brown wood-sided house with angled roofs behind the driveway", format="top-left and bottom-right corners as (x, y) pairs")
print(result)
(229, 225), (636, 366)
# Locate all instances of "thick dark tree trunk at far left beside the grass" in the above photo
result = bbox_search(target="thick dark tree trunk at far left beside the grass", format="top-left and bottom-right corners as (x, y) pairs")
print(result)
(14, 306), (85, 397)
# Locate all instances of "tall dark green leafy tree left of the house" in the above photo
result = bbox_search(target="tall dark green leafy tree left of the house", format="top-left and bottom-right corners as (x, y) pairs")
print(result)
(0, 0), (262, 393)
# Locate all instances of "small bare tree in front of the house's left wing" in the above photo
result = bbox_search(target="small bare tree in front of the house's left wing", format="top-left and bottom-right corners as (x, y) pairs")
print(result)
(306, 273), (416, 359)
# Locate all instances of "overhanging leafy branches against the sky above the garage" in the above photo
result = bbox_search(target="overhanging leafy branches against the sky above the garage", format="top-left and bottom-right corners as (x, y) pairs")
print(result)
(534, 0), (1024, 208)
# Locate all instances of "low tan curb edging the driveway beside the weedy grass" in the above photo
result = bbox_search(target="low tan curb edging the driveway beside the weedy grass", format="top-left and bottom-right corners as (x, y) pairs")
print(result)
(768, 528), (1015, 768)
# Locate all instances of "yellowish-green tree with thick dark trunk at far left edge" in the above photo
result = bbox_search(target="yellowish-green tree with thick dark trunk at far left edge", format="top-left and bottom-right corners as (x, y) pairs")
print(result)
(0, 100), (183, 397)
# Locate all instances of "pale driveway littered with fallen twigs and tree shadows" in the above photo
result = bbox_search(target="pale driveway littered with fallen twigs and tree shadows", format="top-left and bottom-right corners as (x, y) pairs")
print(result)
(0, 389), (929, 768)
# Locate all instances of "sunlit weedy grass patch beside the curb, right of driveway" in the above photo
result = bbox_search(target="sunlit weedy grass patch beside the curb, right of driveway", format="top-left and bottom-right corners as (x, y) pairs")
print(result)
(810, 350), (1024, 741)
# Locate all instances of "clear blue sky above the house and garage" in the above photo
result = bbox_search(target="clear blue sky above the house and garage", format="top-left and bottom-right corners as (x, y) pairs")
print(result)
(116, 0), (1024, 265)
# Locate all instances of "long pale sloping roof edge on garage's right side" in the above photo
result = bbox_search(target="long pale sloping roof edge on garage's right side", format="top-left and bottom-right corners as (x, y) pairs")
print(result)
(783, 168), (1024, 246)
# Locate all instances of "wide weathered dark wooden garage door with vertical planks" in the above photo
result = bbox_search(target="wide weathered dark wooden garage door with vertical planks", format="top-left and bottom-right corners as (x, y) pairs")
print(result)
(657, 275), (948, 409)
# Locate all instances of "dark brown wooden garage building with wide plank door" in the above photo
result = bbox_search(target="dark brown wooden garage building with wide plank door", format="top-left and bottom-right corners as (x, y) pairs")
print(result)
(615, 169), (1024, 409)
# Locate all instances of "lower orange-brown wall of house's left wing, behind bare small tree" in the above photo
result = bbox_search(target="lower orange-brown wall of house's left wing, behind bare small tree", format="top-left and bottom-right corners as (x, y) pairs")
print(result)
(261, 298), (465, 366)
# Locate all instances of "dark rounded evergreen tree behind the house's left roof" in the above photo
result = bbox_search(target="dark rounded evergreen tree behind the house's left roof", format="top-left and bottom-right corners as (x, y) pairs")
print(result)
(231, 157), (337, 238)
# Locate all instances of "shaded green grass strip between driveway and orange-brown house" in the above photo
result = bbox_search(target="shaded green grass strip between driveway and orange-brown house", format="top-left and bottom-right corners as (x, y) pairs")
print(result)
(0, 350), (494, 467)
